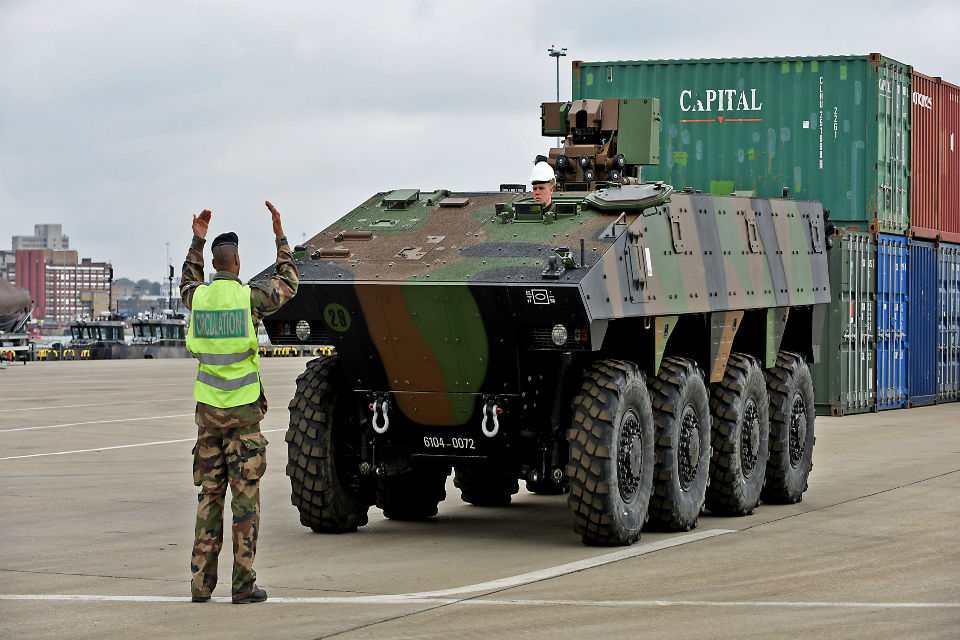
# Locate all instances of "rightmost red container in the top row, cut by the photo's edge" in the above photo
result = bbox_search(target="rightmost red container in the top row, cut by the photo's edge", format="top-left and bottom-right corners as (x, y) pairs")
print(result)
(940, 82), (960, 242)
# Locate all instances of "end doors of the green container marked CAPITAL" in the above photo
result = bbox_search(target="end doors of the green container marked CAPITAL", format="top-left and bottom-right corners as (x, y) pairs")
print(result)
(871, 55), (910, 234)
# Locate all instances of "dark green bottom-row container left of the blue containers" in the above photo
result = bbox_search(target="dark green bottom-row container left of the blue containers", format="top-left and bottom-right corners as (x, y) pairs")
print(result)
(812, 231), (877, 416)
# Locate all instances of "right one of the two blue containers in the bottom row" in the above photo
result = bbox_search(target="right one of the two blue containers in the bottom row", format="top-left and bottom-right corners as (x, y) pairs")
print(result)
(907, 240), (939, 407)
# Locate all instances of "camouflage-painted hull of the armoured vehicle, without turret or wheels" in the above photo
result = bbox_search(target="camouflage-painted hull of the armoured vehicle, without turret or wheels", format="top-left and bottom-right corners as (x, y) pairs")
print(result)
(263, 183), (830, 436)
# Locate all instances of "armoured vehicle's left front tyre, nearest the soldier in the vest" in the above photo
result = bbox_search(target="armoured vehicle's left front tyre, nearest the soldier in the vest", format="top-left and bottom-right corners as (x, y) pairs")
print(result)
(284, 356), (373, 533)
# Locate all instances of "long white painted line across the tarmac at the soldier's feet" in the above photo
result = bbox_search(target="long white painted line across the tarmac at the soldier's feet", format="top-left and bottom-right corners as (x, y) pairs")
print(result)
(0, 594), (960, 609)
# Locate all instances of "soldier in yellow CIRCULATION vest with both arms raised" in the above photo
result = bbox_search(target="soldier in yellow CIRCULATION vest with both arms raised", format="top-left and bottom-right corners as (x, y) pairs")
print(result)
(180, 202), (299, 604)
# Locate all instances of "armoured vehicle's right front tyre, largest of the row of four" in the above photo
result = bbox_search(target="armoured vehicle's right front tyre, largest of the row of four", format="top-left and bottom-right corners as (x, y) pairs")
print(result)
(566, 360), (654, 545)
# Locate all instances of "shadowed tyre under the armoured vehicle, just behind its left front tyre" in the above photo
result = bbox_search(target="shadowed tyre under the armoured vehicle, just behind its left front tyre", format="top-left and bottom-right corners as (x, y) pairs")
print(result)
(377, 467), (450, 520)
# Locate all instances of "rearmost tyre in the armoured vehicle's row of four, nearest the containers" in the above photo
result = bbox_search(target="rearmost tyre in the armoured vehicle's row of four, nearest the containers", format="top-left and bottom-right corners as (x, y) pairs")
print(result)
(760, 351), (816, 504)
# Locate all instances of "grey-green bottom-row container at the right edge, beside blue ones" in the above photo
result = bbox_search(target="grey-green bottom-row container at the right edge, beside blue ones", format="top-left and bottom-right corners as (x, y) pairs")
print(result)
(937, 242), (960, 402)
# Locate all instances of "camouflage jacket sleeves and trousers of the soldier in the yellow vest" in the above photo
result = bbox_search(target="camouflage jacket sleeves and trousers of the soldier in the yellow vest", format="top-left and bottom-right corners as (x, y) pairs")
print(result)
(180, 236), (299, 600)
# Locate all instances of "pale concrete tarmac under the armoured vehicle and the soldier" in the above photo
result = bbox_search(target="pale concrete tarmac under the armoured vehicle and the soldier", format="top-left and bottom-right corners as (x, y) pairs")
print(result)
(0, 358), (960, 639)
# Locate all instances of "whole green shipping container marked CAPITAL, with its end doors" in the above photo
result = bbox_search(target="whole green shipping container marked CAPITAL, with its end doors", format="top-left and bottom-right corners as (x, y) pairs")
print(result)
(573, 54), (910, 234)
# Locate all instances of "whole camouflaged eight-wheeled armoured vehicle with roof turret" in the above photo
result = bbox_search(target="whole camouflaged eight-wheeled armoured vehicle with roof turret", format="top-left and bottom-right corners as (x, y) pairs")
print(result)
(262, 100), (830, 544)
